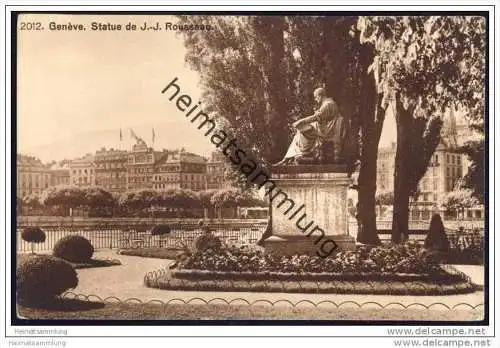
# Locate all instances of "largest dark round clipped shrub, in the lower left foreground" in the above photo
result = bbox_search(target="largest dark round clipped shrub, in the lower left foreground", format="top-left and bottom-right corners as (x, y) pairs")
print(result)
(16, 255), (78, 304)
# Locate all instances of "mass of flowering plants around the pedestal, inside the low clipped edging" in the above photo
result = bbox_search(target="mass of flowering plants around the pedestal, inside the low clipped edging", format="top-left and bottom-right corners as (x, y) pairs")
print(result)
(179, 243), (441, 276)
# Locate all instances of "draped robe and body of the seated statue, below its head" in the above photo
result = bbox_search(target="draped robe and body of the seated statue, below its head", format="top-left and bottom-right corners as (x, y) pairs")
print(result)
(285, 98), (347, 161)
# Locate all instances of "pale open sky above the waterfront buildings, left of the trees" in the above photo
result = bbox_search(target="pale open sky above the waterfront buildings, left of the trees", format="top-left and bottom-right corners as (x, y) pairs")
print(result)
(17, 14), (395, 162)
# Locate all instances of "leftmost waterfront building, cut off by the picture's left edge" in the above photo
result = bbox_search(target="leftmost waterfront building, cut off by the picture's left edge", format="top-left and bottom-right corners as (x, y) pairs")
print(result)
(16, 154), (52, 198)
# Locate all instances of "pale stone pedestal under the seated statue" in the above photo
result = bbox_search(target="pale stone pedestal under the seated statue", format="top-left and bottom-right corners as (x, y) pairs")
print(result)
(264, 165), (355, 257)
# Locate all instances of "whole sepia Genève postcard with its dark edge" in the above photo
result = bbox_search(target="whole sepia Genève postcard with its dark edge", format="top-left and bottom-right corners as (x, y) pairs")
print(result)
(2, 6), (494, 347)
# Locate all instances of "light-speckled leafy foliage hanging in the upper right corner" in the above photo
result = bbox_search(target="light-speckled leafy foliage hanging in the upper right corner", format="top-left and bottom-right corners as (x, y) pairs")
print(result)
(358, 16), (486, 121)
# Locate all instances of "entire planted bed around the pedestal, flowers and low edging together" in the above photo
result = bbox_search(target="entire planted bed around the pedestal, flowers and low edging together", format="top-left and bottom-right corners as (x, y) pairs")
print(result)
(145, 243), (476, 295)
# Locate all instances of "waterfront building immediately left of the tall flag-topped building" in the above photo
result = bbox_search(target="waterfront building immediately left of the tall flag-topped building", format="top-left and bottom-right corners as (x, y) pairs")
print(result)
(95, 147), (128, 193)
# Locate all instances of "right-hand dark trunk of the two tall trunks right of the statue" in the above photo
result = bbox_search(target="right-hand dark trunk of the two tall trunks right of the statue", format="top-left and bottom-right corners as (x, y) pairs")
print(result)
(391, 96), (413, 243)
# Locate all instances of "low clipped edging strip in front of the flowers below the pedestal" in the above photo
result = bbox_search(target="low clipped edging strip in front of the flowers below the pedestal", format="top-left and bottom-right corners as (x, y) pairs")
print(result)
(144, 269), (476, 296)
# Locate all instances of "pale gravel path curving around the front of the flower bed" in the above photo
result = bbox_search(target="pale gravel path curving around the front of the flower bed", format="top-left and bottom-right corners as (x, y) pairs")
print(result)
(71, 251), (484, 310)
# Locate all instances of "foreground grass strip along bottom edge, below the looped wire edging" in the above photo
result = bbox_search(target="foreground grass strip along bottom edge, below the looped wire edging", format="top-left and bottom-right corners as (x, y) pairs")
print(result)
(18, 299), (483, 321)
